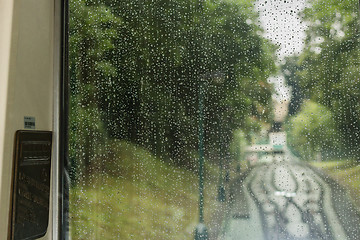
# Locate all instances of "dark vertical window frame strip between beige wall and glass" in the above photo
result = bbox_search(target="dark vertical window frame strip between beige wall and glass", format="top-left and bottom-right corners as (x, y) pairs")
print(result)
(52, 0), (70, 240)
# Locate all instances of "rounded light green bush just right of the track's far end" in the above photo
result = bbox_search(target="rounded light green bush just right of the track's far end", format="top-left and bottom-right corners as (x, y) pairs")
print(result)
(286, 101), (341, 161)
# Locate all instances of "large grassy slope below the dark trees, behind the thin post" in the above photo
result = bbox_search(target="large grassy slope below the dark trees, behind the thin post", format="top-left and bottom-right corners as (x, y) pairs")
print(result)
(70, 142), (233, 240)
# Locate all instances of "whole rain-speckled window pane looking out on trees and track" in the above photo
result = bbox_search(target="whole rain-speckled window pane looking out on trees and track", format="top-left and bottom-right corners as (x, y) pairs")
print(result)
(69, 0), (360, 240)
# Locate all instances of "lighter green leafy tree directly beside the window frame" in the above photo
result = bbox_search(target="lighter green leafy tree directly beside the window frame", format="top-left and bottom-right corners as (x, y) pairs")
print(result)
(69, 0), (121, 178)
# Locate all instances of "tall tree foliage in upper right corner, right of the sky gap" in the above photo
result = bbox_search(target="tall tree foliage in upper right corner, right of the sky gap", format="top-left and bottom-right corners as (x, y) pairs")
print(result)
(299, 0), (360, 156)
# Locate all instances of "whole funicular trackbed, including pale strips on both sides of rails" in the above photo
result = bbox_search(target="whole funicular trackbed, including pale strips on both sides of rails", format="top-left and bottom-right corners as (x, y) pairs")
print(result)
(216, 160), (360, 240)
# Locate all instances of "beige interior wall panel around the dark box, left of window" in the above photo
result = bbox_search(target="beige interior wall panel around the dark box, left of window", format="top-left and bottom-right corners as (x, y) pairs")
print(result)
(0, 0), (54, 238)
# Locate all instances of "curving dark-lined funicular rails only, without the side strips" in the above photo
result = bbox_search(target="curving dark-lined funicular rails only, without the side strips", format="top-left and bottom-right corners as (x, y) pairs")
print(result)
(246, 162), (334, 240)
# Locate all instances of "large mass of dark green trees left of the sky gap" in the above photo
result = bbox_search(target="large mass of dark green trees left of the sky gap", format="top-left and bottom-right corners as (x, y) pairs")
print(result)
(69, 0), (275, 176)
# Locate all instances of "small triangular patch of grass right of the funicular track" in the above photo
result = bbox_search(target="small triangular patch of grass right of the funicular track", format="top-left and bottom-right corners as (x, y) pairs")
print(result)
(311, 160), (360, 209)
